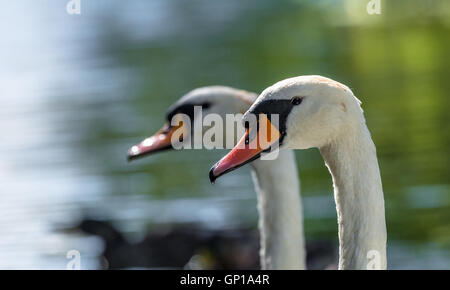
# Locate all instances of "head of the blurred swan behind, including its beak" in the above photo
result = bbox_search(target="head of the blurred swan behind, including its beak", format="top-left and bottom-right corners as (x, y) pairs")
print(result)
(127, 86), (257, 160)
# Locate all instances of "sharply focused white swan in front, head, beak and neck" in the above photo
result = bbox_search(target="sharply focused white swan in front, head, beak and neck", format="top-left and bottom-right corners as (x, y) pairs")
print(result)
(210, 76), (386, 269)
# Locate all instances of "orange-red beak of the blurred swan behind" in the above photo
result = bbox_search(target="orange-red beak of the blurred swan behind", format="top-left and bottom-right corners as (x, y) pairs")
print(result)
(127, 120), (183, 161)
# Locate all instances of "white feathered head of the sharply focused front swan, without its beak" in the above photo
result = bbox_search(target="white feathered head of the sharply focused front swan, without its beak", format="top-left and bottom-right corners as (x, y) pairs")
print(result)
(255, 76), (362, 149)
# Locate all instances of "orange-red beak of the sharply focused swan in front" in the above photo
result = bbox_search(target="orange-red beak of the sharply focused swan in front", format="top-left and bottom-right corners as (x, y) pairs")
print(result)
(209, 114), (281, 183)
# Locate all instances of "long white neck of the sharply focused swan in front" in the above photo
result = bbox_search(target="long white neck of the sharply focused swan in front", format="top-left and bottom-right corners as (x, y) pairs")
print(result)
(320, 123), (386, 269)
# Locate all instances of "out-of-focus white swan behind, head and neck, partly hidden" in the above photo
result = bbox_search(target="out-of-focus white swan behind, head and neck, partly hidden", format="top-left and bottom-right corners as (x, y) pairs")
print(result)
(128, 86), (306, 269)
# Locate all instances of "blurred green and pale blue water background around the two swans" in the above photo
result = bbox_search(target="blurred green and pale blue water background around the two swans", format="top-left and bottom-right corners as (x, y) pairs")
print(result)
(0, 0), (450, 269)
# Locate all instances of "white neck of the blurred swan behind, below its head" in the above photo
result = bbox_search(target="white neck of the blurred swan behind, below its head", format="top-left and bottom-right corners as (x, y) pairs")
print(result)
(252, 150), (306, 269)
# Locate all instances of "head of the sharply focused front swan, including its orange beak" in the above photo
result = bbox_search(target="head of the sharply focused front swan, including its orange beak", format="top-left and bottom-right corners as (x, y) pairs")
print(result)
(210, 76), (364, 181)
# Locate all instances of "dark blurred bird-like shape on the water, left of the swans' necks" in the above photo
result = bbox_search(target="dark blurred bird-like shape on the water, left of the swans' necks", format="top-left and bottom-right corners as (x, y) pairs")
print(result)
(71, 220), (259, 270)
